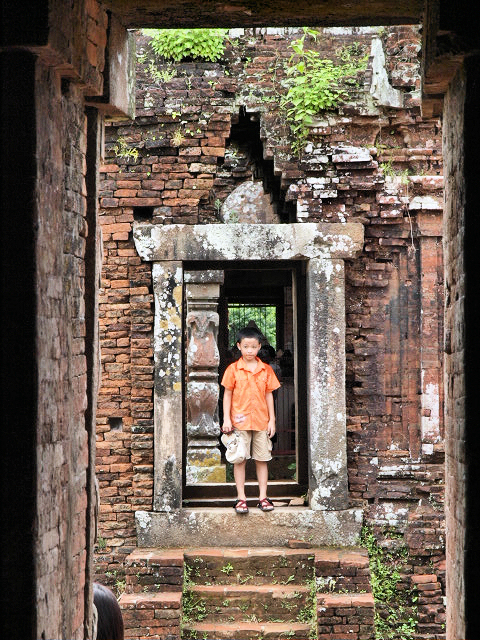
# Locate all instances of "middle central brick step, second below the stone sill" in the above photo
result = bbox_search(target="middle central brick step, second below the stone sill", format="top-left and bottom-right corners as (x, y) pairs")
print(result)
(188, 584), (310, 622)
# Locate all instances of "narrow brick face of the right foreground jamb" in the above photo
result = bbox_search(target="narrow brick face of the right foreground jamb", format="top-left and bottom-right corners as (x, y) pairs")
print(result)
(444, 58), (467, 638)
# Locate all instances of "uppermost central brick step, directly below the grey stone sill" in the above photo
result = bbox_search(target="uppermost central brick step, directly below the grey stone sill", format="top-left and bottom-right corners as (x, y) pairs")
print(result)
(184, 547), (315, 585)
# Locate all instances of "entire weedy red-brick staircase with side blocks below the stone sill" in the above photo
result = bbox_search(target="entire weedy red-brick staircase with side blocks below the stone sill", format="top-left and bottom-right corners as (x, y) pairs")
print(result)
(120, 540), (375, 640)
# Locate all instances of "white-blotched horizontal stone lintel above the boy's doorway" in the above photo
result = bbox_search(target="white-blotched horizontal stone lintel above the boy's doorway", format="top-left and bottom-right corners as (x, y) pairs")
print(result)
(133, 222), (363, 261)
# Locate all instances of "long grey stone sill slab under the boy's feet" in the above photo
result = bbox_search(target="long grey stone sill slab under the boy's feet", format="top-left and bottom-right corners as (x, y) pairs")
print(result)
(135, 507), (363, 548)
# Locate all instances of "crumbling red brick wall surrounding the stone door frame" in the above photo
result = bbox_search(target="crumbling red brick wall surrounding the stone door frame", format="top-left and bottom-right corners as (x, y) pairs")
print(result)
(96, 27), (444, 637)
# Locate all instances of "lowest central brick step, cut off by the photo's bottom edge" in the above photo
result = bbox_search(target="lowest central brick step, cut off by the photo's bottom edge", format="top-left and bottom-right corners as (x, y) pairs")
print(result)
(182, 622), (311, 640)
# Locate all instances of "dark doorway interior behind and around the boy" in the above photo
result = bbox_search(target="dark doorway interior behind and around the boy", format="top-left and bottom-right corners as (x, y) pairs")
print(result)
(184, 261), (308, 506)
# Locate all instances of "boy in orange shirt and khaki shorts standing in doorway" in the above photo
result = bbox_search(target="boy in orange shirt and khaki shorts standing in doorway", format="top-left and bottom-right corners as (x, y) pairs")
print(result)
(222, 327), (280, 513)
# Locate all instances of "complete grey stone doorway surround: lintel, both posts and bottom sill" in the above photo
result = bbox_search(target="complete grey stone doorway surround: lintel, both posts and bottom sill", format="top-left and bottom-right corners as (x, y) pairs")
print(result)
(134, 223), (363, 546)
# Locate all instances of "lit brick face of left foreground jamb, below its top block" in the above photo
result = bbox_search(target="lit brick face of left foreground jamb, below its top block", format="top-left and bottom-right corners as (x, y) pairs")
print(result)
(37, 63), (88, 637)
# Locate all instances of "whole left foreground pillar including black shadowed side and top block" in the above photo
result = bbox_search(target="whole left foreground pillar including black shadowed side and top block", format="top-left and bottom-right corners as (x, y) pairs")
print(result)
(1, 0), (136, 638)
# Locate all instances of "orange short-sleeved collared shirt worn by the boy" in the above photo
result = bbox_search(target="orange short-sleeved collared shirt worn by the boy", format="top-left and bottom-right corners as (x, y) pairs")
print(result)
(222, 358), (280, 431)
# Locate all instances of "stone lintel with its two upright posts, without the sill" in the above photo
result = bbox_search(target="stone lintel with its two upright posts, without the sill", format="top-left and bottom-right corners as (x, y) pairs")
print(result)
(134, 222), (363, 513)
